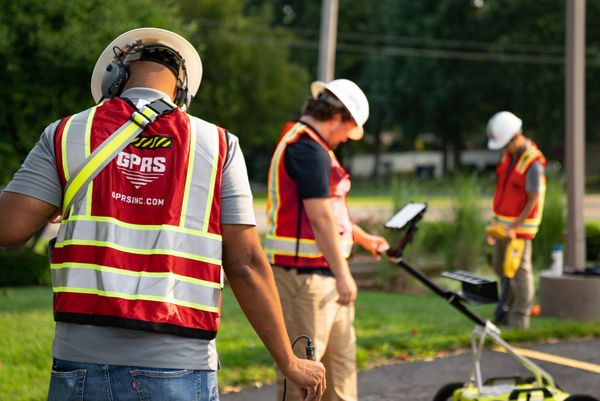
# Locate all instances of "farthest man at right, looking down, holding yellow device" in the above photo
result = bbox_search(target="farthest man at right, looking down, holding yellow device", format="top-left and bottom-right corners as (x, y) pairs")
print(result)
(487, 111), (546, 328)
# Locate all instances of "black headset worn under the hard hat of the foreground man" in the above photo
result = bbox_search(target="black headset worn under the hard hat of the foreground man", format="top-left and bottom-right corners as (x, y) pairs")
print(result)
(100, 41), (192, 110)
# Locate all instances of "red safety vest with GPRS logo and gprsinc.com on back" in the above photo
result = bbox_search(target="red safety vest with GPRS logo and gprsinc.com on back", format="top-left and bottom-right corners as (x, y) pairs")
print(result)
(51, 98), (227, 339)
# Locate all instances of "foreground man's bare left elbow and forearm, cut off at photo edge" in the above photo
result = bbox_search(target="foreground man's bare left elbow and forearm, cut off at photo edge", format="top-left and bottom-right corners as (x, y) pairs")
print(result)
(0, 191), (57, 246)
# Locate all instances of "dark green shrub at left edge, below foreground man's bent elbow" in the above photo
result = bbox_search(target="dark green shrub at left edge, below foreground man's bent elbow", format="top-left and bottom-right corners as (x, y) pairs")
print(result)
(0, 247), (50, 287)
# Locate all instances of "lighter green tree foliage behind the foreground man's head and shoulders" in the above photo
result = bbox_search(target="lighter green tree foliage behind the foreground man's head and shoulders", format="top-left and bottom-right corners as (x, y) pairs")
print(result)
(0, 0), (308, 185)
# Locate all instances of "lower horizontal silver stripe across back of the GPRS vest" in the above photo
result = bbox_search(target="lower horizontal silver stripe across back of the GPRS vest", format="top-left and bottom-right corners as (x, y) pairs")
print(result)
(52, 266), (221, 312)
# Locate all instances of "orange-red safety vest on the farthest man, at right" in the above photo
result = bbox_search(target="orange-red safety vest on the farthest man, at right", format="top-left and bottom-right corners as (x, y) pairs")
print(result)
(493, 142), (546, 239)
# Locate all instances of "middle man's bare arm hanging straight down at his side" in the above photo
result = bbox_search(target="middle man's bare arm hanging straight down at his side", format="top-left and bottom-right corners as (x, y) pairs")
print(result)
(303, 198), (358, 305)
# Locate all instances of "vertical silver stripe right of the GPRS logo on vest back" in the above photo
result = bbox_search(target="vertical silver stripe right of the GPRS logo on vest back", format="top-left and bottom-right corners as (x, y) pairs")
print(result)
(183, 116), (219, 230)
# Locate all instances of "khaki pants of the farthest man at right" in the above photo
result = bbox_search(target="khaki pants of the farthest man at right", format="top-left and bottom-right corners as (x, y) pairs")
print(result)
(494, 240), (535, 328)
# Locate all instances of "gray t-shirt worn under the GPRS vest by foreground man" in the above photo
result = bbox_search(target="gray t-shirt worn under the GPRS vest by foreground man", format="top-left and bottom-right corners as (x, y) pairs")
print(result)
(4, 88), (256, 370)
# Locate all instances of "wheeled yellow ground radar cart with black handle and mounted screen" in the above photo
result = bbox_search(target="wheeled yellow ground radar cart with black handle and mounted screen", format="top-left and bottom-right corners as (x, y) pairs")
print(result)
(385, 203), (598, 401)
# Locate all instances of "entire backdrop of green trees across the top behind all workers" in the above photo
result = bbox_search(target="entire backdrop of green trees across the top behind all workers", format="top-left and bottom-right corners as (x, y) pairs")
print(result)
(0, 0), (600, 185)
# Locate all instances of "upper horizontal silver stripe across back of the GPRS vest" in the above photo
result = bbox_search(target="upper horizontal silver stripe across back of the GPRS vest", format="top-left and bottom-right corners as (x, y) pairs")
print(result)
(56, 217), (222, 265)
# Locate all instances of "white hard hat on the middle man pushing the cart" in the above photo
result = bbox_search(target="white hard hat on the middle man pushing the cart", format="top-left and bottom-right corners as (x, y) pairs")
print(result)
(310, 79), (369, 140)
